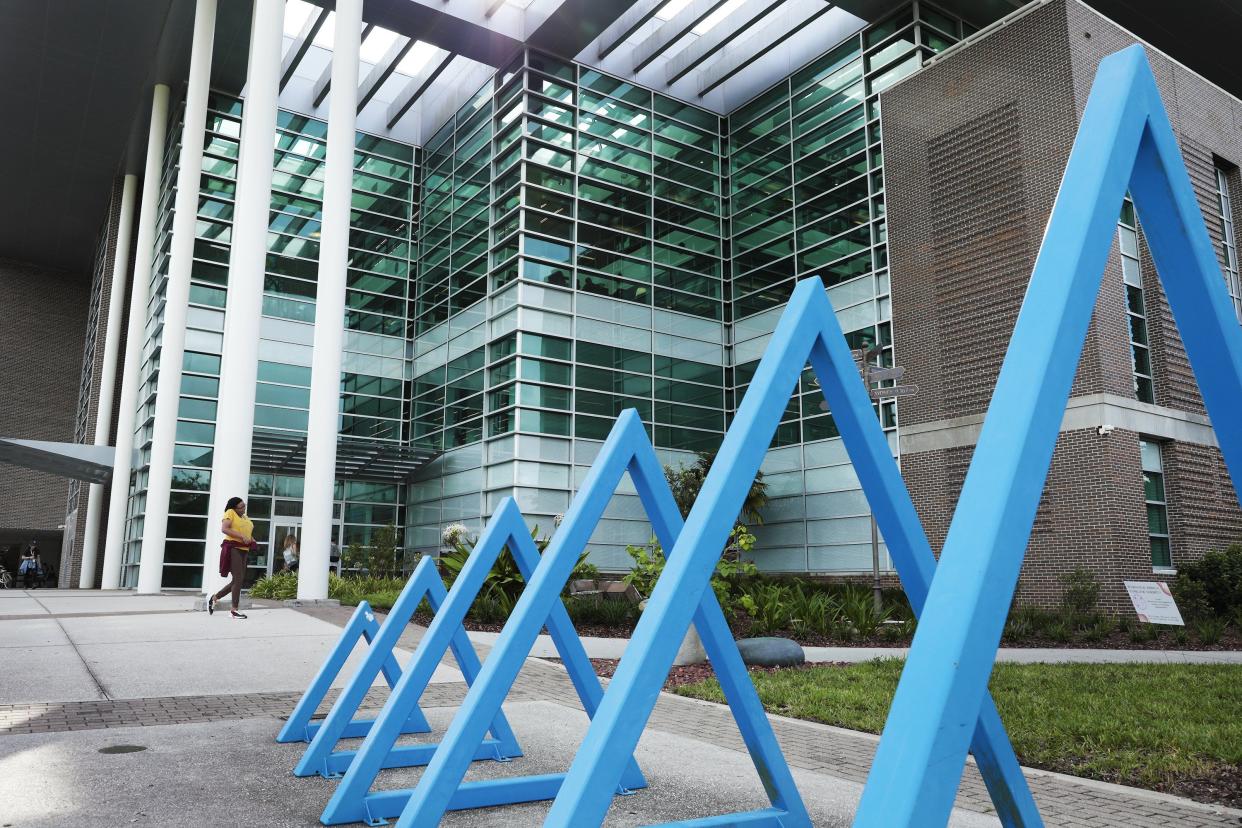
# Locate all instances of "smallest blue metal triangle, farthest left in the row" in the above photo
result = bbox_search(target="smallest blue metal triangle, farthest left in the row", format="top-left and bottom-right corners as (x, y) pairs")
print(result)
(276, 598), (431, 742)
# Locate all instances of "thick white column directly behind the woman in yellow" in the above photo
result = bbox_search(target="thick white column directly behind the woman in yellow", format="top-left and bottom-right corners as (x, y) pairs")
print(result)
(202, 0), (284, 593)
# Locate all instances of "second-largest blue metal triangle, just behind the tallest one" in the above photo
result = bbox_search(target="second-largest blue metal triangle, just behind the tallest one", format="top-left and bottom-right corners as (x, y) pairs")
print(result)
(545, 271), (1042, 827)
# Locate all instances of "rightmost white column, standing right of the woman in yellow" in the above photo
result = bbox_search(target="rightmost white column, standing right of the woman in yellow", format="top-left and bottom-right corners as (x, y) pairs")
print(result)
(298, 0), (363, 601)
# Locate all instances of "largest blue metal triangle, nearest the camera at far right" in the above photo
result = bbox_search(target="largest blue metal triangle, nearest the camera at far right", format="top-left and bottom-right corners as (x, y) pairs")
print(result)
(859, 46), (1242, 827)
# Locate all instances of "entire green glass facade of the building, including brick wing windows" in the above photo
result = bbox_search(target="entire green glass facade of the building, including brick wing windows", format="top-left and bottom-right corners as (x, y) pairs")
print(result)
(127, 2), (1228, 587)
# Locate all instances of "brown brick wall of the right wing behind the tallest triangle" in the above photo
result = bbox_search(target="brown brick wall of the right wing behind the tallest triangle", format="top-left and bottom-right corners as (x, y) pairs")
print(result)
(882, 0), (1242, 611)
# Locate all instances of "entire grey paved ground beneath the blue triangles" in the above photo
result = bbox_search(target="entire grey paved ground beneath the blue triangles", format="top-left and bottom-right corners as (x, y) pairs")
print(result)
(0, 592), (1242, 828)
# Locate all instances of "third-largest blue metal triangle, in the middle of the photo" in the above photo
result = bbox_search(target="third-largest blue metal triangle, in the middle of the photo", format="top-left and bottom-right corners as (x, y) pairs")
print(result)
(394, 414), (814, 828)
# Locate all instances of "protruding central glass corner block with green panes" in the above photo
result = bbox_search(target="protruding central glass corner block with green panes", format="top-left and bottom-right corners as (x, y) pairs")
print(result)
(410, 52), (727, 567)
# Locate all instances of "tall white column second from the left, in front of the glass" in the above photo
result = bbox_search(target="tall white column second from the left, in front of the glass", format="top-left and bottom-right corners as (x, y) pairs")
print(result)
(103, 83), (168, 590)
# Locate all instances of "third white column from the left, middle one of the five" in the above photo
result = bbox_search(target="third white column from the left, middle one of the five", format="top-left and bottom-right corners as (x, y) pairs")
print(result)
(138, 0), (216, 593)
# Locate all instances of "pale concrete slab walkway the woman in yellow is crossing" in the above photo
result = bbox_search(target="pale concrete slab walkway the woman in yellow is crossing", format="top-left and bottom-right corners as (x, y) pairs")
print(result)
(0, 590), (462, 704)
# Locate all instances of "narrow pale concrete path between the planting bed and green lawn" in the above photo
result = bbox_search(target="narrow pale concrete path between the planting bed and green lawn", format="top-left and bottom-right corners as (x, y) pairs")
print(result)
(469, 632), (1242, 664)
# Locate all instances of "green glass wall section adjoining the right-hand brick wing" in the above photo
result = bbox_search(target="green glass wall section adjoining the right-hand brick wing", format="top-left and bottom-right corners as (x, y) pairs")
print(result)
(727, 2), (974, 572)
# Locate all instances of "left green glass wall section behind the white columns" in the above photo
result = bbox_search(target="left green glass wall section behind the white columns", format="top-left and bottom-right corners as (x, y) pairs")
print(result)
(125, 93), (419, 588)
